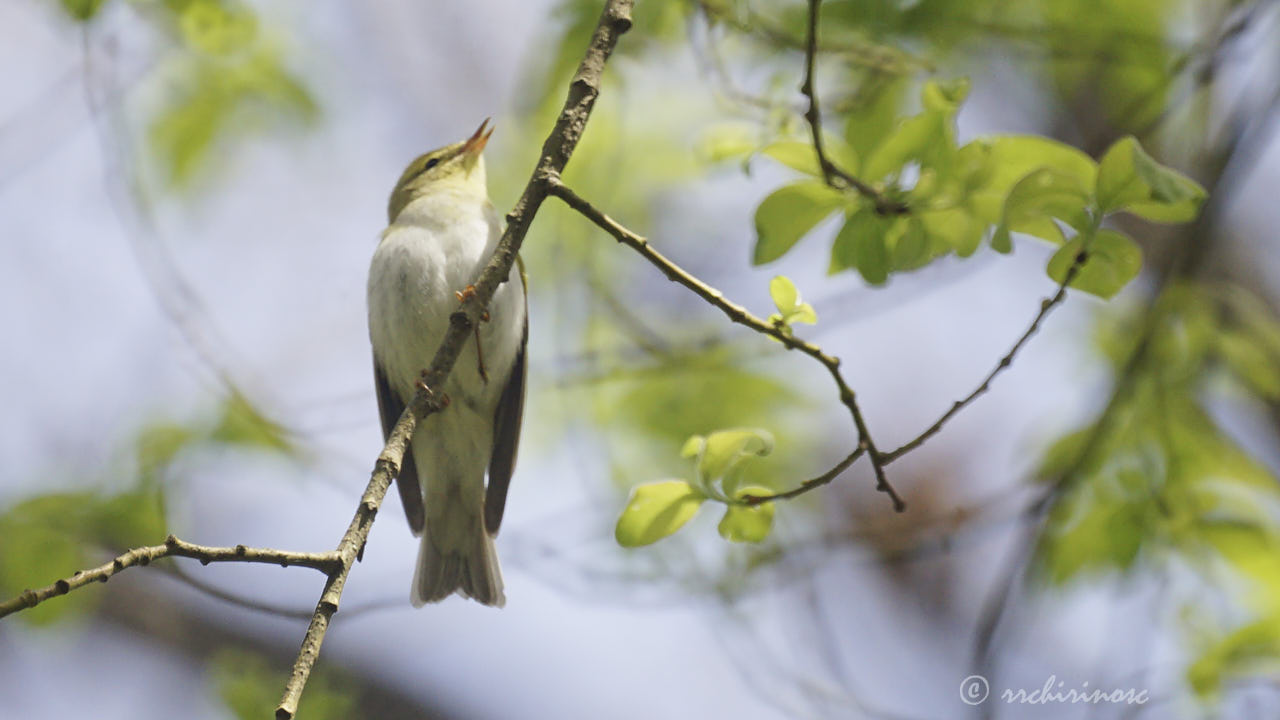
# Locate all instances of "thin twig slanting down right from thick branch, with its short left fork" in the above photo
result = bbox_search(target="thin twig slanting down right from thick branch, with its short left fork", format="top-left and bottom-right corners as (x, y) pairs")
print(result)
(547, 174), (906, 512)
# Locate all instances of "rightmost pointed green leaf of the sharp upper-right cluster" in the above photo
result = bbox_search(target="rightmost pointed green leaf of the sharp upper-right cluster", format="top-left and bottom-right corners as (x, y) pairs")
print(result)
(1096, 136), (1206, 223)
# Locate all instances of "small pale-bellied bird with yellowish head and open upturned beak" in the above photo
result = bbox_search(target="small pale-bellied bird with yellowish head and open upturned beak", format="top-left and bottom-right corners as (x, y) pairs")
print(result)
(369, 120), (529, 607)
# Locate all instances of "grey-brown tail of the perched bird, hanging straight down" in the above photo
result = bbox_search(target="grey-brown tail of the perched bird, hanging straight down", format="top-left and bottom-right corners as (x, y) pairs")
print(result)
(410, 486), (507, 607)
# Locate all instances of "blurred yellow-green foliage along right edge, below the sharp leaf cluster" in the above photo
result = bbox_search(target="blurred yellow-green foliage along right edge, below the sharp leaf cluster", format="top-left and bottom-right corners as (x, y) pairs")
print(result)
(1034, 284), (1280, 696)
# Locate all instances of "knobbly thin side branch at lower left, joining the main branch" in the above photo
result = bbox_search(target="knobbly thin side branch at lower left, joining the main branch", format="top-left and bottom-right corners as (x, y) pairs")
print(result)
(0, 536), (339, 618)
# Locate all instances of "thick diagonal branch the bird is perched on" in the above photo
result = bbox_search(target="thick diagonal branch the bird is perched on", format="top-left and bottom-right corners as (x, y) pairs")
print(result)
(275, 0), (632, 720)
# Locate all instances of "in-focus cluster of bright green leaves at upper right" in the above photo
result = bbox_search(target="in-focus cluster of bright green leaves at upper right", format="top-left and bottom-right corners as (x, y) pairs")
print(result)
(727, 81), (1204, 297)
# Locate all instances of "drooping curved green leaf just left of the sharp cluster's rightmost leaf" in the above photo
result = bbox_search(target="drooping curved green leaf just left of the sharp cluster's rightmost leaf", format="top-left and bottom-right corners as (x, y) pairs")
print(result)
(992, 168), (1089, 252)
